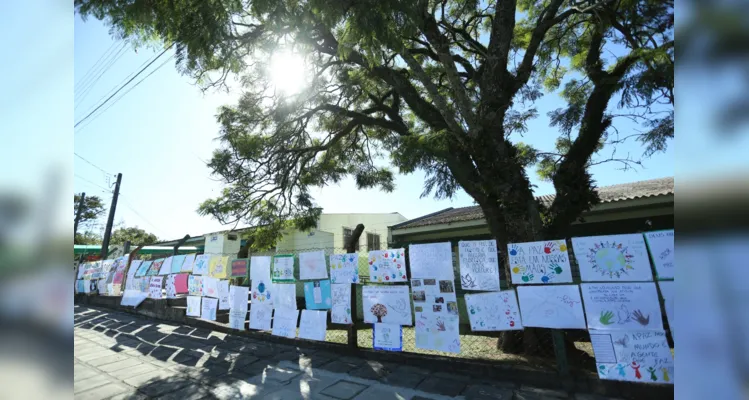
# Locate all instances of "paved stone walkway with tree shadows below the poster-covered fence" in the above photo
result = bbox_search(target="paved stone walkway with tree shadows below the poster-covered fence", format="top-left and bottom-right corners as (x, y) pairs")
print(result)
(74, 306), (616, 400)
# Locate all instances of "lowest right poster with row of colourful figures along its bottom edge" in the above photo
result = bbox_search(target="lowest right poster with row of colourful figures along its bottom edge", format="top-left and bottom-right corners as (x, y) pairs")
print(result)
(590, 331), (674, 385)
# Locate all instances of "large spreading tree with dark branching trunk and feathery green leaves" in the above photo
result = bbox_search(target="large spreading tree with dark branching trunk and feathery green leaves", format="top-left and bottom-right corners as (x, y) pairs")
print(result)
(76, 0), (674, 354)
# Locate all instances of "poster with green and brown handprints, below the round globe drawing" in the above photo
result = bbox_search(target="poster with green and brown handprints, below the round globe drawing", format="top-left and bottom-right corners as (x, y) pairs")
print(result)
(580, 282), (663, 331)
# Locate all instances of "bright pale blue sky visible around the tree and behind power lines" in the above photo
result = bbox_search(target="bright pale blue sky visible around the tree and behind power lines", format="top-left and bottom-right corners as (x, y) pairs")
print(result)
(74, 16), (674, 239)
